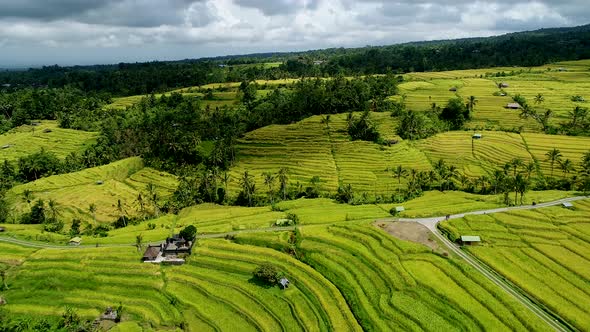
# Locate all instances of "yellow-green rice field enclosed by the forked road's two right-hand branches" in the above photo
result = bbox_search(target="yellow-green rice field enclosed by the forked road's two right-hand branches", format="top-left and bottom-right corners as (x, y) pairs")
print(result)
(441, 200), (590, 331)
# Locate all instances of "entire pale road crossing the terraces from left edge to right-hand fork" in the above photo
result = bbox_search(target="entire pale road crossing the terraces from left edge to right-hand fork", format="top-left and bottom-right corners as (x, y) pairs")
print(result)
(0, 196), (590, 331)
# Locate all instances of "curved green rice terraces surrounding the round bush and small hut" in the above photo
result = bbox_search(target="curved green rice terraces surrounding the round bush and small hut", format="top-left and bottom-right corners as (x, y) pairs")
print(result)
(167, 240), (361, 331)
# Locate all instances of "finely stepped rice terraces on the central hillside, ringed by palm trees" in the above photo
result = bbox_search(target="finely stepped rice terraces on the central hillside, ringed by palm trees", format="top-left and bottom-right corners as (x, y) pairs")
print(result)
(230, 113), (431, 194)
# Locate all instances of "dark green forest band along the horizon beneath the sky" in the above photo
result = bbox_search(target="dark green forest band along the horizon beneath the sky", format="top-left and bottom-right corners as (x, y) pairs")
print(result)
(0, 25), (590, 96)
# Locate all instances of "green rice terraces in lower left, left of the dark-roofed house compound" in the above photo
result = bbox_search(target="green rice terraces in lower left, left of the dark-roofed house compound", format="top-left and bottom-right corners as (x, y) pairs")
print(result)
(0, 248), (181, 327)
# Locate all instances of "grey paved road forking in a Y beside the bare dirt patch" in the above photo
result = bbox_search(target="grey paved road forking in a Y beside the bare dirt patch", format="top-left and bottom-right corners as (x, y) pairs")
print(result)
(377, 196), (590, 331)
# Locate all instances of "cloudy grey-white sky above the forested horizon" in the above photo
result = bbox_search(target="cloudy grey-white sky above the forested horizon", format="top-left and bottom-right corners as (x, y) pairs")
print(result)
(0, 0), (590, 68)
